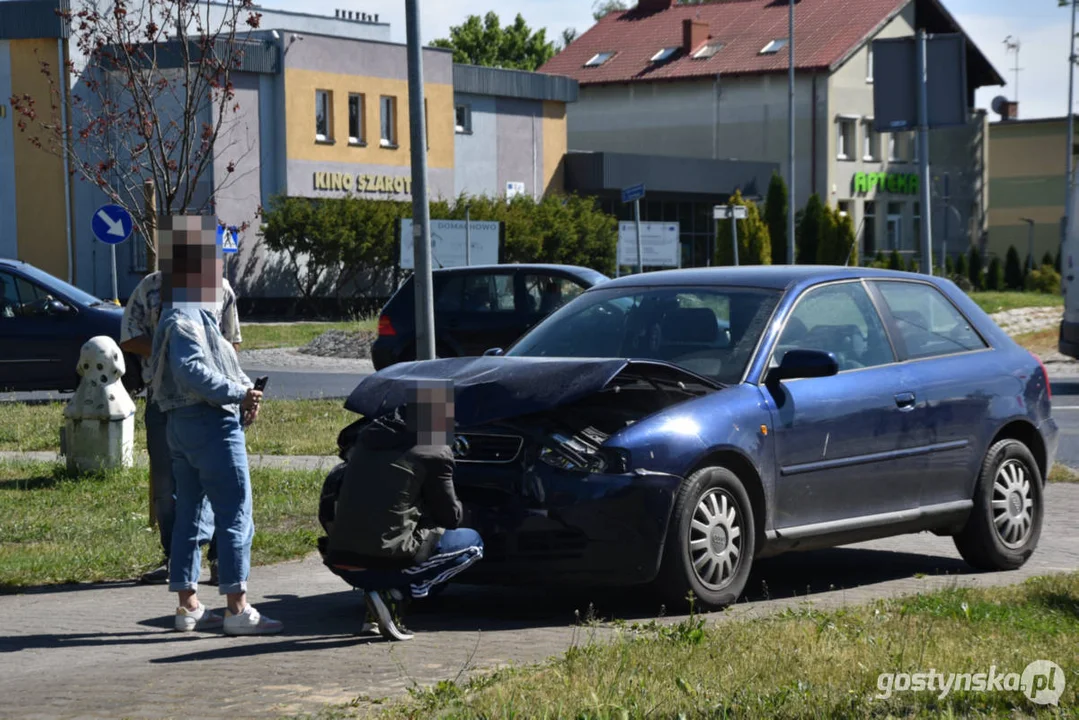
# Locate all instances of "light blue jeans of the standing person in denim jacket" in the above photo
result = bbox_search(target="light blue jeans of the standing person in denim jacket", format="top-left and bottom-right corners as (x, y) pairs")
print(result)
(168, 405), (255, 595)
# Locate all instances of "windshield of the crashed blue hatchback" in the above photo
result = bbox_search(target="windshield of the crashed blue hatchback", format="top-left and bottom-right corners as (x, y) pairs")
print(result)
(506, 287), (780, 384)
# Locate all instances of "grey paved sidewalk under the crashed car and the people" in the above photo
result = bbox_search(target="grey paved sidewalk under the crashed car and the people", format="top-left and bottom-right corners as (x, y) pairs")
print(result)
(0, 485), (1079, 719)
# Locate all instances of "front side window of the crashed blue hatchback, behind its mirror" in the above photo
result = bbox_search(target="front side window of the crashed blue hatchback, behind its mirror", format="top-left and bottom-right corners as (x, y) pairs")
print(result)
(773, 283), (896, 372)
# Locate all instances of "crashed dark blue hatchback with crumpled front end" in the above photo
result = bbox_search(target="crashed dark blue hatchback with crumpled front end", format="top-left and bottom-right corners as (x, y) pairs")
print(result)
(323, 267), (1057, 608)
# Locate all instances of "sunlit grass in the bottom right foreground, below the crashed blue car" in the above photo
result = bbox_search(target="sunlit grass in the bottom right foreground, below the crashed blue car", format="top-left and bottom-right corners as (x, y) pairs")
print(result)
(356, 574), (1079, 719)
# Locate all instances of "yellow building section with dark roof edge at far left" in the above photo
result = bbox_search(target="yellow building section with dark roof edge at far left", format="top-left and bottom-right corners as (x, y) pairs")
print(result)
(0, 0), (76, 281)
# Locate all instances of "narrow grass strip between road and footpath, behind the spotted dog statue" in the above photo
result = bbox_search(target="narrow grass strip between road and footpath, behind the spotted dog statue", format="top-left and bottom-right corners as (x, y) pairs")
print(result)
(0, 397), (356, 454)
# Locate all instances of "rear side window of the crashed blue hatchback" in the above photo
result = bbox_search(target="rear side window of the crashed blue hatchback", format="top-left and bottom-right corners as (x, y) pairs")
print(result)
(876, 281), (987, 358)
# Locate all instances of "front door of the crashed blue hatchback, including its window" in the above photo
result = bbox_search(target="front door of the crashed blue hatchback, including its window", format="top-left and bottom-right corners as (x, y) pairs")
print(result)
(765, 281), (920, 536)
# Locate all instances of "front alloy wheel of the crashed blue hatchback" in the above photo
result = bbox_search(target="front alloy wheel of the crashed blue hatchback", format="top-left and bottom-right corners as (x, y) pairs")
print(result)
(689, 488), (742, 590)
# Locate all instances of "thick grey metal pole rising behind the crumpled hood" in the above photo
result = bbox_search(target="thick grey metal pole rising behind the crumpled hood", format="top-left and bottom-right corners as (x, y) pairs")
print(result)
(405, 0), (435, 359)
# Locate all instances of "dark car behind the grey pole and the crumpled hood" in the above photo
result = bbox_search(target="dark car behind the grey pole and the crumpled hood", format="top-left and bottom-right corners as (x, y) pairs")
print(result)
(371, 264), (606, 370)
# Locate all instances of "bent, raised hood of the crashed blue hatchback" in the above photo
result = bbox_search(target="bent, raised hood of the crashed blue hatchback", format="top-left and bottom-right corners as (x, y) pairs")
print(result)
(344, 356), (714, 427)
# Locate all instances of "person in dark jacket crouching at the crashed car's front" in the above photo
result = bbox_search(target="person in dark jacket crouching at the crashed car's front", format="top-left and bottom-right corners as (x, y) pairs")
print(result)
(326, 380), (483, 640)
